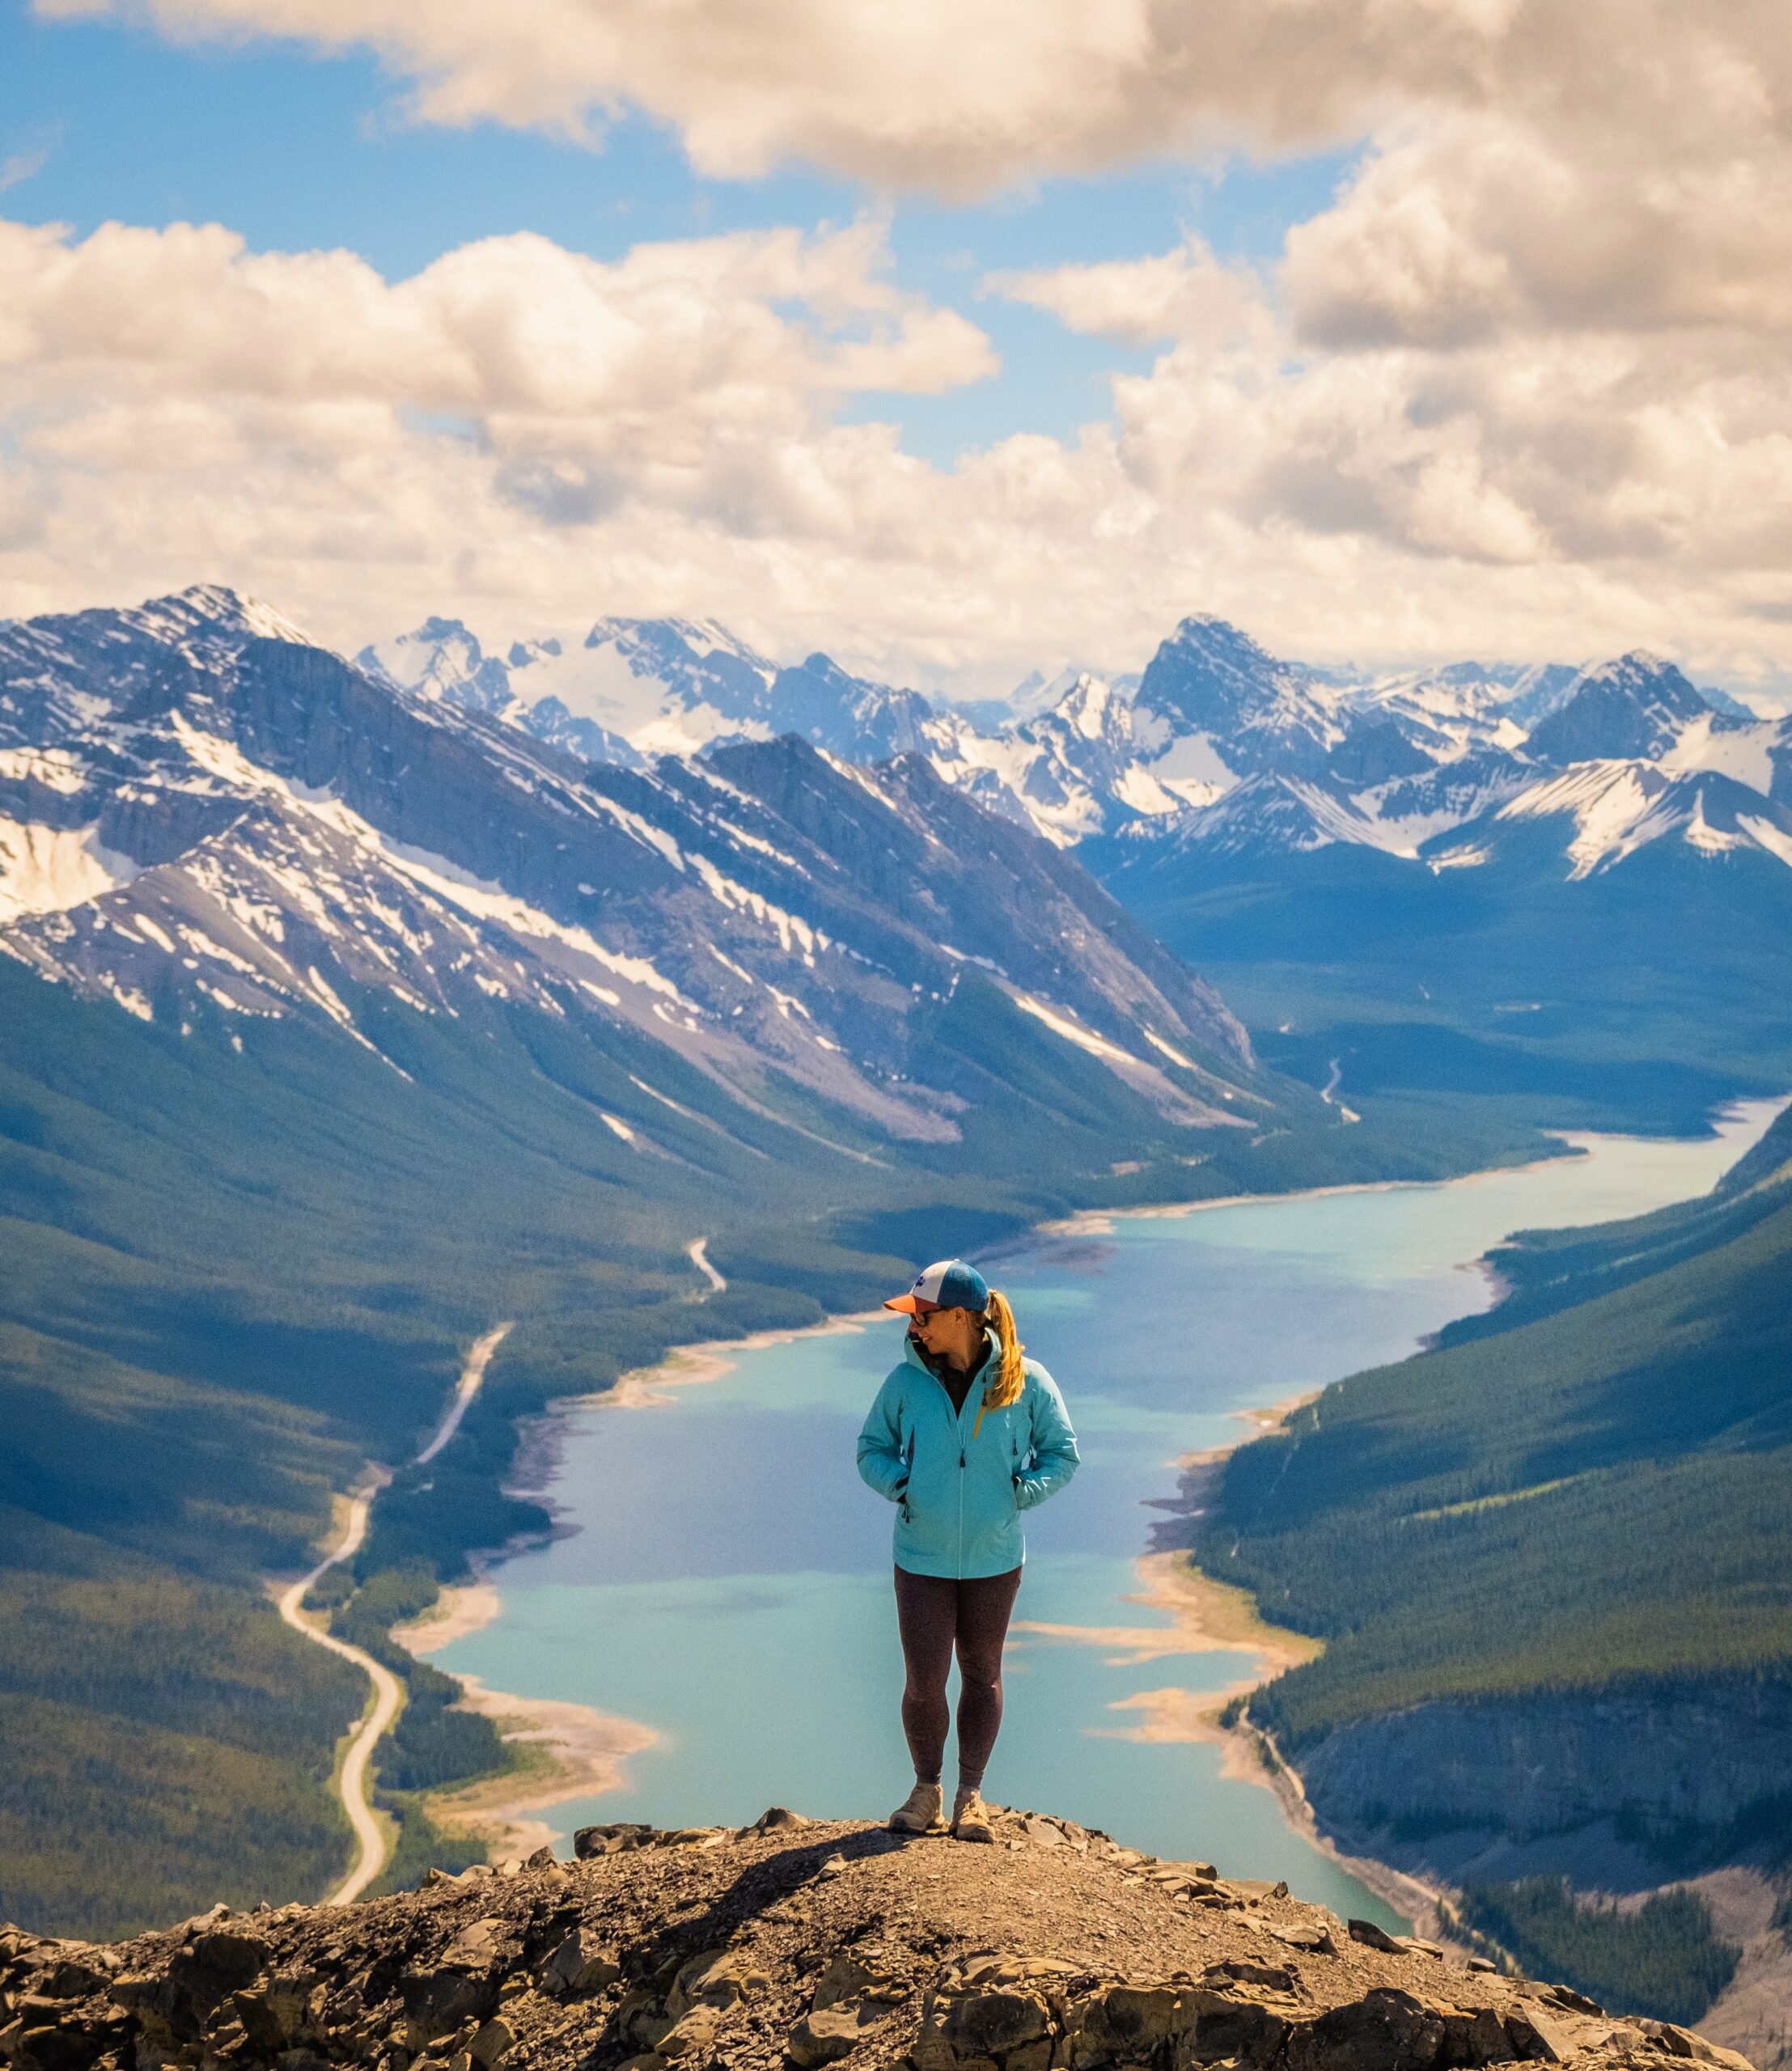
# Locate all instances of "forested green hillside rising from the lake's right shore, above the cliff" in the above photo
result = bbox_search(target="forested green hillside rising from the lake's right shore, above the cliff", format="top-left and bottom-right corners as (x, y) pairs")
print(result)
(1197, 1110), (1792, 1781)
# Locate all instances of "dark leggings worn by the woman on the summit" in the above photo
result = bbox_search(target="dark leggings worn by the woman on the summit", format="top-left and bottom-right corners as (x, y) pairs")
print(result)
(897, 1568), (1021, 1791)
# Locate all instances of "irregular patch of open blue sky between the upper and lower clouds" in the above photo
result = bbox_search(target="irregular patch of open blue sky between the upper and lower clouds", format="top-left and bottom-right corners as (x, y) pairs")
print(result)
(0, 0), (1349, 464)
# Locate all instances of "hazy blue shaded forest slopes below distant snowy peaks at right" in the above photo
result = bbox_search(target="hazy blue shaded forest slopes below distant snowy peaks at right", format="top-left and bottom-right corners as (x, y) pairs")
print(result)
(1079, 822), (1792, 1131)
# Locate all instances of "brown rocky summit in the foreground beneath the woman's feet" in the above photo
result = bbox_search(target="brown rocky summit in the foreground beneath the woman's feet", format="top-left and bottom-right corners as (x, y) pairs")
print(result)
(0, 1808), (1748, 2071)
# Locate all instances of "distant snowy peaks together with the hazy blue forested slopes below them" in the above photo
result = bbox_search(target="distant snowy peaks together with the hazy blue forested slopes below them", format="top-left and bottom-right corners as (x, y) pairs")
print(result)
(345, 592), (1792, 1129)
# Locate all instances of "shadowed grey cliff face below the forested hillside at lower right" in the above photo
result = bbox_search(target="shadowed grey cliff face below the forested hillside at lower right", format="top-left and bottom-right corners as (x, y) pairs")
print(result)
(1299, 1678), (1792, 1876)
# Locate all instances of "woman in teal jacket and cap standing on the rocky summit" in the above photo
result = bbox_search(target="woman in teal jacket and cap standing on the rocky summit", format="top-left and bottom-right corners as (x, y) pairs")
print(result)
(858, 1259), (1078, 1841)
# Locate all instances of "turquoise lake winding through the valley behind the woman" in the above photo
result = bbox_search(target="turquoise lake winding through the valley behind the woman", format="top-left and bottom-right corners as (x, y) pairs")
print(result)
(433, 1102), (1780, 1922)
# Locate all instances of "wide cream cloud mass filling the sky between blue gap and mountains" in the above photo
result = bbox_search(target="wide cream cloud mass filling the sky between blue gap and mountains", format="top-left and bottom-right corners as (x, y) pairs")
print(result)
(0, 199), (1792, 689)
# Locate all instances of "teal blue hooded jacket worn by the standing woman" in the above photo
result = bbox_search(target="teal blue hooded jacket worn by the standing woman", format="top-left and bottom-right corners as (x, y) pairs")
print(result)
(858, 1340), (1078, 1580)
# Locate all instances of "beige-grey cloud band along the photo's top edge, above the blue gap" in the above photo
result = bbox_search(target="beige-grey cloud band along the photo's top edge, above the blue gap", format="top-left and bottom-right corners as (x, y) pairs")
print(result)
(36, 0), (1792, 193)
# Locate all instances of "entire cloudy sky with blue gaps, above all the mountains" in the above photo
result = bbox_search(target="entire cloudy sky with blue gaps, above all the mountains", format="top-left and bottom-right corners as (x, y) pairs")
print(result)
(0, 0), (1792, 696)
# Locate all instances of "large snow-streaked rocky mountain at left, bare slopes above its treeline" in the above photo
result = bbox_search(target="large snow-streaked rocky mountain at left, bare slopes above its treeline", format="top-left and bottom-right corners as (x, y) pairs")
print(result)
(0, 591), (1272, 1150)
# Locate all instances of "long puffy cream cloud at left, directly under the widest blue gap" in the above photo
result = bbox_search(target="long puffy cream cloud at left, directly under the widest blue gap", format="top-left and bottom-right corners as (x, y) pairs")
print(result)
(0, 222), (997, 420)
